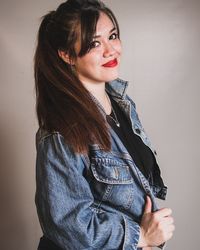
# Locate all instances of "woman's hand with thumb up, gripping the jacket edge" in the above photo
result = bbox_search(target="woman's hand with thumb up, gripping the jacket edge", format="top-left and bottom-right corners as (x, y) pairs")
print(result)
(138, 196), (175, 247)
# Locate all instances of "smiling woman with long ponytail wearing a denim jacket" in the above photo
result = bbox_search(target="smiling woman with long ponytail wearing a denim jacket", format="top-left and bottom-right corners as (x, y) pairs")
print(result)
(35, 0), (174, 250)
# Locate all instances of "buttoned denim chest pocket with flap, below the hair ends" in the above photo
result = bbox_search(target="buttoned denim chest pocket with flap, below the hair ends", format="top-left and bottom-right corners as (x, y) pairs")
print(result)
(91, 158), (135, 210)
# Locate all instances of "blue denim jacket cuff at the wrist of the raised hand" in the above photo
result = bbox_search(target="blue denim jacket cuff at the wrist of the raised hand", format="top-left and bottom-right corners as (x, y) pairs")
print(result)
(123, 217), (140, 250)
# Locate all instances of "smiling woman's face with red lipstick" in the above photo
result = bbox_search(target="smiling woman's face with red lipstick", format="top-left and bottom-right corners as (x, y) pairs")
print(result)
(74, 13), (121, 85)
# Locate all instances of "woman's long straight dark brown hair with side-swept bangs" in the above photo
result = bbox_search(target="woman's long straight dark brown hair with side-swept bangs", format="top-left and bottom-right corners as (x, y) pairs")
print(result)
(34, 0), (119, 153)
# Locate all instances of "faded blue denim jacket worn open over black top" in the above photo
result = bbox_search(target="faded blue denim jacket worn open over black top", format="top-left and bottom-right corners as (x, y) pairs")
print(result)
(35, 79), (166, 250)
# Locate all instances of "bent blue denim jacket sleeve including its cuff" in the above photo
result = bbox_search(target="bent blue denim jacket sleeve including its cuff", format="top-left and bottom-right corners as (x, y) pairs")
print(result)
(35, 133), (140, 250)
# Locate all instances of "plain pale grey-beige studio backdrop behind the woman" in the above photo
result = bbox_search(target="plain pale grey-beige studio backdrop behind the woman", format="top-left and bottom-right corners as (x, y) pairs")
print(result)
(0, 0), (200, 250)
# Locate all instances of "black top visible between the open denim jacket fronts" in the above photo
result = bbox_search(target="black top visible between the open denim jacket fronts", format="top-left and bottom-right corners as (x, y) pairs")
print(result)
(106, 95), (164, 186)
